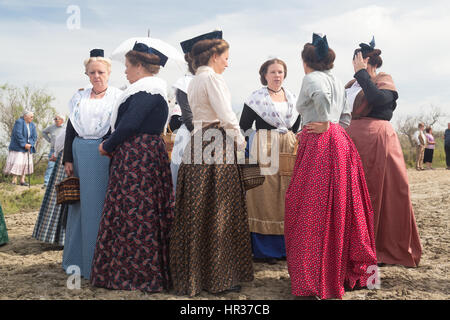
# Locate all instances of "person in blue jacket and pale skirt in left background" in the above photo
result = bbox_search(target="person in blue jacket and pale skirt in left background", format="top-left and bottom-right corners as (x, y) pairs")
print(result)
(3, 110), (37, 186)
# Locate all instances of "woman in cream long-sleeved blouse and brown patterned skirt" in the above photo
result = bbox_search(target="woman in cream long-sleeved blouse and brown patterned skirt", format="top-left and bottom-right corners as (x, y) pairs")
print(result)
(169, 35), (253, 296)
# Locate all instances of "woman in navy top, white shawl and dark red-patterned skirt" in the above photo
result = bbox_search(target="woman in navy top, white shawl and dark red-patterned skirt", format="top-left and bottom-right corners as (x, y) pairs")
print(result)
(91, 43), (174, 292)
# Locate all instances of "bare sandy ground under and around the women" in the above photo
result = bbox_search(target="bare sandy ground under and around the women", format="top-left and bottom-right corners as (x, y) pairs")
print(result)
(0, 169), (450, 300)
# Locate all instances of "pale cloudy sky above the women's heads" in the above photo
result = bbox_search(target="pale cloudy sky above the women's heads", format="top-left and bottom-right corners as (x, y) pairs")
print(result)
(0, 0), (450, 128)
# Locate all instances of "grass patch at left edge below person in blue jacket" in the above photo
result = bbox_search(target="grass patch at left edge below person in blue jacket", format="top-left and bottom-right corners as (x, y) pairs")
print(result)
(0, 183), (44, 214)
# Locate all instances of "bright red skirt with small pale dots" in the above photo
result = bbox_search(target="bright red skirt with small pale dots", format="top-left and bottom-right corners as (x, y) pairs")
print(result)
(285, 124), (377, 299)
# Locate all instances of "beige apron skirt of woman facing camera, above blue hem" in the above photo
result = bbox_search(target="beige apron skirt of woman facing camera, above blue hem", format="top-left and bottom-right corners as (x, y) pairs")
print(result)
(246, 130), (297, 235)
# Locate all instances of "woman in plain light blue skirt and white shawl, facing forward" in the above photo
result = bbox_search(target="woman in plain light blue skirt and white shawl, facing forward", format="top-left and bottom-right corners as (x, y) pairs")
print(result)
(62, 49), (122, 279)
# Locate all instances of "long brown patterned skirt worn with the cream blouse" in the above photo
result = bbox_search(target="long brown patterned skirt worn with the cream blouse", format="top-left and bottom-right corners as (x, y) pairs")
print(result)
(170, 125), (253, 296)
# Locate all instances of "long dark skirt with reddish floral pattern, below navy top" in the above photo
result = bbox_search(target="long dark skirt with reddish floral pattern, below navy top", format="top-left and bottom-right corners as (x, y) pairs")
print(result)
(91, 134), (174, 292)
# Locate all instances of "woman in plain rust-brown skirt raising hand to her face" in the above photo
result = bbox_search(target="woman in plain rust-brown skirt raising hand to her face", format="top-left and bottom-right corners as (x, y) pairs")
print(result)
(346, 40), (422, 267)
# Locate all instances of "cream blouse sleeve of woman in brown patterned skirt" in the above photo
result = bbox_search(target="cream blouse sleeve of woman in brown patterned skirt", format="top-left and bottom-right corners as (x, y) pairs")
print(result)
(206, 74), (245, 145)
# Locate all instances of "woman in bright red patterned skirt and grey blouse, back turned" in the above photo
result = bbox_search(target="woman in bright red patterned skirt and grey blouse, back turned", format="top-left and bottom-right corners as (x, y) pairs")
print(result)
(285, 34), (377, 299)
